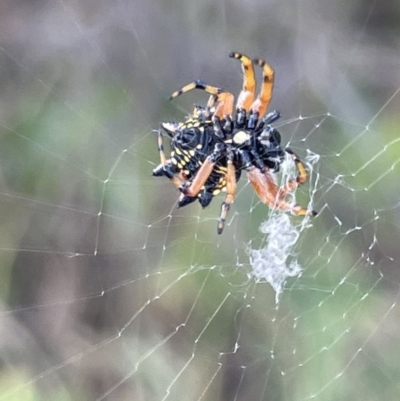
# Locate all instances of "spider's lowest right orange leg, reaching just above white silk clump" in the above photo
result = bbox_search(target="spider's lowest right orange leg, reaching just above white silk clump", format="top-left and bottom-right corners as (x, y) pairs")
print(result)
(247, 167), (317, 216)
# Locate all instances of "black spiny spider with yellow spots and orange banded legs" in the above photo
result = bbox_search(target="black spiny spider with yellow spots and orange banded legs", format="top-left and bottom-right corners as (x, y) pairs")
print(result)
(153, 52), (317, 234)
